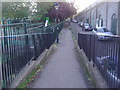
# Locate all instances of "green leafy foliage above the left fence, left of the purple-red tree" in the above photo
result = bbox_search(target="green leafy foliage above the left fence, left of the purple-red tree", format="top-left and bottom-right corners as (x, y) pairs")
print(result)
(2, 2), (54, 22)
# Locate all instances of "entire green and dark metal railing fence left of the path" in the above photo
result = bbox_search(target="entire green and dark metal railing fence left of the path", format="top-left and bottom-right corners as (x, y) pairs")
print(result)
(0, 18), (63, 88)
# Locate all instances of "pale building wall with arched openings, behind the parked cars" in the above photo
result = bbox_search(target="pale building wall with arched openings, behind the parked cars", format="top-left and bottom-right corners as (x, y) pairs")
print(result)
(78, 2), (120, 34)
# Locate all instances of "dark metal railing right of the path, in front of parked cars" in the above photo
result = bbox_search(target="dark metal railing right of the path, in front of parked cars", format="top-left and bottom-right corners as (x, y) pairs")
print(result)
(78, 33), (120, 88)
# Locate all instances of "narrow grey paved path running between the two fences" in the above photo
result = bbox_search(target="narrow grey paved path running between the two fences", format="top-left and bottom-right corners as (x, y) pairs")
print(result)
(29, 29), (87, 88)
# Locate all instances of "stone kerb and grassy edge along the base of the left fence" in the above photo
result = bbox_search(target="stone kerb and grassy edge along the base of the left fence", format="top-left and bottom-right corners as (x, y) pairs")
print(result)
(8, 43), (56, 88)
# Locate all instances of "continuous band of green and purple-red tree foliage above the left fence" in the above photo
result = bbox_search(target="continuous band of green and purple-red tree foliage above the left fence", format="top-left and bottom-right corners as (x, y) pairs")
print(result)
(2, 2), (76, 22)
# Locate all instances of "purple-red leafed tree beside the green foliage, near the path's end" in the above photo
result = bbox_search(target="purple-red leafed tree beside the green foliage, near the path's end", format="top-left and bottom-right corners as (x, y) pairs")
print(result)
(48, 2), (77, 21)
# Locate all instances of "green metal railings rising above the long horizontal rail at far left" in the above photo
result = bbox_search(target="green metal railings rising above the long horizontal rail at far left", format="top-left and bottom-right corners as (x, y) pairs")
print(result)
(0, 19), (44, 36)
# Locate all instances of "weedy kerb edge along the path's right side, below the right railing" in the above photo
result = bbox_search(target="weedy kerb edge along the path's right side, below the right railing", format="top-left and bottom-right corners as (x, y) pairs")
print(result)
(71, 31), (109, 88)
